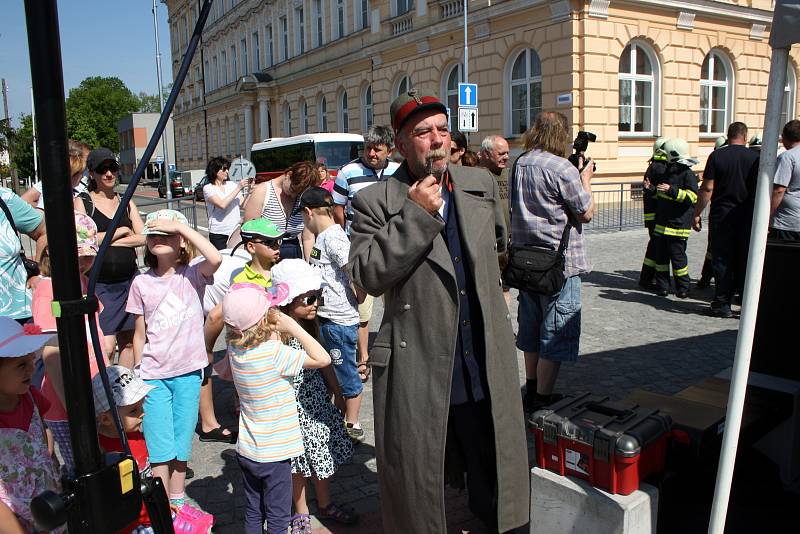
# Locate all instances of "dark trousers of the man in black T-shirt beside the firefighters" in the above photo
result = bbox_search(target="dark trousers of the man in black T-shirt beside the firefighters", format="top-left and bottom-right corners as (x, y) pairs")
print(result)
(710, 217), (750, 306)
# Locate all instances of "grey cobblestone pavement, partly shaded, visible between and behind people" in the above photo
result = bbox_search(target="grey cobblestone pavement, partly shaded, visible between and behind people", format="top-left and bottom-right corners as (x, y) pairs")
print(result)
(186, 229), (738, 533)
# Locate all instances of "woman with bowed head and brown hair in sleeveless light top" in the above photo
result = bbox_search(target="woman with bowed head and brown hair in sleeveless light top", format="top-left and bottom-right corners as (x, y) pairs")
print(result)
(244, 161), (319, 260)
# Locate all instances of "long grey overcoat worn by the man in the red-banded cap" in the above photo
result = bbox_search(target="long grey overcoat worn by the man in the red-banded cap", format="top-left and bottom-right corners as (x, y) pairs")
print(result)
(348, 164), (530, 534)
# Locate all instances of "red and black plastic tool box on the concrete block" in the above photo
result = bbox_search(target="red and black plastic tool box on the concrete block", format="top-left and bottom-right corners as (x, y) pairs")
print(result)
(530, 393), (672, 495)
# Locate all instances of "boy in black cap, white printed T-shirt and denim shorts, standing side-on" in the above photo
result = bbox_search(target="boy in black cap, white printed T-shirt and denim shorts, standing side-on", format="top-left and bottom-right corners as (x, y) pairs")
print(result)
(300, 187), (364, 442)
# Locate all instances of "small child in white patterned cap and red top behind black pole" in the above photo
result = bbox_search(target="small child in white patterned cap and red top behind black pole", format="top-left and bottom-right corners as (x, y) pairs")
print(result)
(92, 365), (153, 534)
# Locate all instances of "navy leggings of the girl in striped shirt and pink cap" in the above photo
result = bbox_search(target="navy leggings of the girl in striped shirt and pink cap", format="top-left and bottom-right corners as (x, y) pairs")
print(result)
(236, 454), (292, 534)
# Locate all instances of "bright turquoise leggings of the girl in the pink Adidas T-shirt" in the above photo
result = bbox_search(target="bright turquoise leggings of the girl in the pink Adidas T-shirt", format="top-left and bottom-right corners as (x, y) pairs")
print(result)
(142, 370), (203, 463)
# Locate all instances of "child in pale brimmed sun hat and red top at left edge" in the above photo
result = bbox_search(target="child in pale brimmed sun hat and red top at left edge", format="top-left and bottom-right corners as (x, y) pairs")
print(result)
(0, 317), (60, 533)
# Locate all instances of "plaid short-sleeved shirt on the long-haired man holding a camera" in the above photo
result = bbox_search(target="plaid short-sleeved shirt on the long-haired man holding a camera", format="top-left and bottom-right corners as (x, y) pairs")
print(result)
(509, 150), (592, 277)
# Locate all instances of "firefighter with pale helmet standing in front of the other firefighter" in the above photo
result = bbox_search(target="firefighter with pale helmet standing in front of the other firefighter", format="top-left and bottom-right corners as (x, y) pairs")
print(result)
(653, 138), (698, 299)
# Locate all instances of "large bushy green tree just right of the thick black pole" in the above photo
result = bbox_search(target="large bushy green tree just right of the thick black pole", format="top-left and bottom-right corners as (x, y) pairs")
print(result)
(67, 76), (140, 152)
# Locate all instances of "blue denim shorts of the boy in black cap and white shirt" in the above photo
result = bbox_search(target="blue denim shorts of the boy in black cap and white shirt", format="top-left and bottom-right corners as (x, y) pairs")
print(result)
(318, 317), (364, 399)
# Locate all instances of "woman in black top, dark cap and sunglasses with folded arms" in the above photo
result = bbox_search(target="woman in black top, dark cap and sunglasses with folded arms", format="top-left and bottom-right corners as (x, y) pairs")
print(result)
(75, 148), (145, 367)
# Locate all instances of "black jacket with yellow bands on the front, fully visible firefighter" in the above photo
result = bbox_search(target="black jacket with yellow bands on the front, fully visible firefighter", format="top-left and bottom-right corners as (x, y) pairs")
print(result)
(653, 163), (697, 239)
